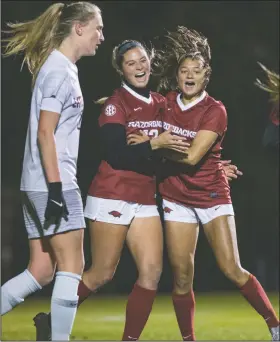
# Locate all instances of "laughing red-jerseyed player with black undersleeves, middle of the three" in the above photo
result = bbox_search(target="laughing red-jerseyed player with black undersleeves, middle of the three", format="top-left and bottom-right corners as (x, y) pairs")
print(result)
(82, 40), (188, 341)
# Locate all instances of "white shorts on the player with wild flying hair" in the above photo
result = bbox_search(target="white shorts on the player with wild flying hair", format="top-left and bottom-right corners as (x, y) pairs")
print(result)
(162, 199), (234, 224)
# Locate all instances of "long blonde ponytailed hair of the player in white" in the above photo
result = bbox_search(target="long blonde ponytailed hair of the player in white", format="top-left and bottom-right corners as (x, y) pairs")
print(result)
(2, 1), (101, 86)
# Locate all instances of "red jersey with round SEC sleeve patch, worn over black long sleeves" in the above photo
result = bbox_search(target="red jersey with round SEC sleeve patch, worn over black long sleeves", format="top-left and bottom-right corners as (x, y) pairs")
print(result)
(89, 84), (166, 204)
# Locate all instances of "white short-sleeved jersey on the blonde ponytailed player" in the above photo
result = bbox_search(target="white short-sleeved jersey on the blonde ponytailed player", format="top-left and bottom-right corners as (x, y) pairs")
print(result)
(20, 50), (84, 191)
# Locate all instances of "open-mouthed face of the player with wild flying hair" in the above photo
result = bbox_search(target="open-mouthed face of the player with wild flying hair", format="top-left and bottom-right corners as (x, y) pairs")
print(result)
(177, 58), (207, 104)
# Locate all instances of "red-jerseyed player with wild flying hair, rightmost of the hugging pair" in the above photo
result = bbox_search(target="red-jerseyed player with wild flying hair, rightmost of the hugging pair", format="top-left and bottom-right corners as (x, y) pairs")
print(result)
(154, 27), (279, 341)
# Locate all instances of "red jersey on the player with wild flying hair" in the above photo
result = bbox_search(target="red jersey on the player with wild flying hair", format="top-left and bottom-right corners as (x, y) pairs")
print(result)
(159, 92), (231, 208)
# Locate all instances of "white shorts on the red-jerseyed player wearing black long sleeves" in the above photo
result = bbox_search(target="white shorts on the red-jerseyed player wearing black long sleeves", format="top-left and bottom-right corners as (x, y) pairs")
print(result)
(84, 196), (159, 225)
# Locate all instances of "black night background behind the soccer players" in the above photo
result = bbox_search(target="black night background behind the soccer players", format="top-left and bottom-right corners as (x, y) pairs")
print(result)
(1, 1), (279, 294)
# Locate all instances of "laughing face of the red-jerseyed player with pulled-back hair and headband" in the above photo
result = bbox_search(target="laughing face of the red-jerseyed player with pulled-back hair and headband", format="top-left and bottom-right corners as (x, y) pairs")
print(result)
(122, 47), (151, 88)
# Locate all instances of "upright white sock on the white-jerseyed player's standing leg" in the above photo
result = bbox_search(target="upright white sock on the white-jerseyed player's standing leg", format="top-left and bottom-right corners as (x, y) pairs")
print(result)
(51, 272), (82, 341)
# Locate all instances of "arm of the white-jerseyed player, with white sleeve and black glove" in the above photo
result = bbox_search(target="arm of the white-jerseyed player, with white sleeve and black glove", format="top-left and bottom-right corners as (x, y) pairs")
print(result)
(37, 70), (70, 223)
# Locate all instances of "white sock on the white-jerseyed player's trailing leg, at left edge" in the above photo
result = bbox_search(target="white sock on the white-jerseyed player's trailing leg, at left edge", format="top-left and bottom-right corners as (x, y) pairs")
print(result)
(1, 270), (42, 316)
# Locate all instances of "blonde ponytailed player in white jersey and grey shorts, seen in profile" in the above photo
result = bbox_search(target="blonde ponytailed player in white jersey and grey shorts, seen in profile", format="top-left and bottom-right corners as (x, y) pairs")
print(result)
(1, 2), (104, 340)
